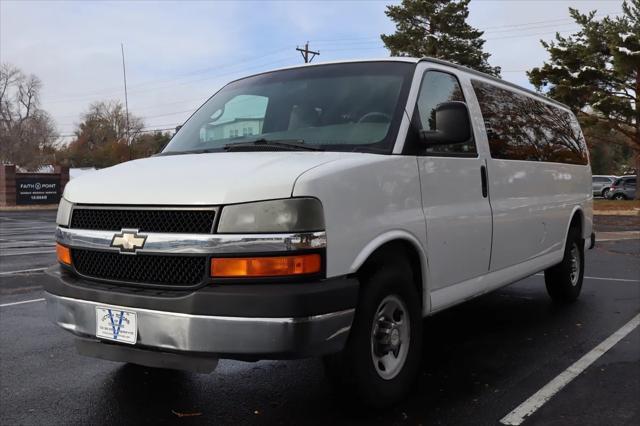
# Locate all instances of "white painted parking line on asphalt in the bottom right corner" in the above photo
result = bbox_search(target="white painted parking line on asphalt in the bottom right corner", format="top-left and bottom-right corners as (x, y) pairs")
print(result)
(500, 314), (640, 425)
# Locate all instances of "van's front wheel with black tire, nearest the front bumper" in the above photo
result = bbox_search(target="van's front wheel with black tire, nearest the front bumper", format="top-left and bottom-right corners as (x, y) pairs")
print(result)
(324, 257), (422, 408)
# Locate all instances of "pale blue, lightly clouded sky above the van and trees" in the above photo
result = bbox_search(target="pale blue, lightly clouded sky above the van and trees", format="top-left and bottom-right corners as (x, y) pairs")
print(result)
(0, 0), (622, 140)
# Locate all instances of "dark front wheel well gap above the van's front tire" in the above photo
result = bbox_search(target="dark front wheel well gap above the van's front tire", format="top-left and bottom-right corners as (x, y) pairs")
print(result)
(356, 240), (423, 305)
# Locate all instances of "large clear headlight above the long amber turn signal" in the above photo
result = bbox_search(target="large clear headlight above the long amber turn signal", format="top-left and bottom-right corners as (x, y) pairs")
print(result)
(218, 198), (324, 233)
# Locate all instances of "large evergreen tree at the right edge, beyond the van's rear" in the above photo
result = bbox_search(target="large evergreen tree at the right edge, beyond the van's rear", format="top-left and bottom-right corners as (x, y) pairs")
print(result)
(527, 0), (640, 198)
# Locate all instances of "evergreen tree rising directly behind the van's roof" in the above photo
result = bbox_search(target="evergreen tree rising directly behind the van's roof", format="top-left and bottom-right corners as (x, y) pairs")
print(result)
(380, 0), (500, 76)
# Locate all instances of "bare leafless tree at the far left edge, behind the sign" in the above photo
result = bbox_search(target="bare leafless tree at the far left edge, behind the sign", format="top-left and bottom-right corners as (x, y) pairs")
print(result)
(0, 64), (57, 169)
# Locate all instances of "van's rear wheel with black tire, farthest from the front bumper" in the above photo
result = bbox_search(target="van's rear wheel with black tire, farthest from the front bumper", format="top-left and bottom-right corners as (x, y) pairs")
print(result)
(544, 227), (584, 303)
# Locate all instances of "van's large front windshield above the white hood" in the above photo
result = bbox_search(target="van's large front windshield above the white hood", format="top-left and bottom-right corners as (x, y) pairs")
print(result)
(163, 62), (415, 154)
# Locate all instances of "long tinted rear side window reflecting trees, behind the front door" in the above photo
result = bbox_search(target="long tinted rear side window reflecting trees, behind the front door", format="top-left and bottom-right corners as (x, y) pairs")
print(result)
(472, 80), (587, 164)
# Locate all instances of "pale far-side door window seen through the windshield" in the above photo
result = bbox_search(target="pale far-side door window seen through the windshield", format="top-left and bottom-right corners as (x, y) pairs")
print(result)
(200, 95), (269, 142)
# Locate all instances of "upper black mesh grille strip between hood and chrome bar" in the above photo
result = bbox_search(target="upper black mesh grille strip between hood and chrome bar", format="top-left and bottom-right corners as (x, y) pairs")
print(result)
(70, 207), (216, 234)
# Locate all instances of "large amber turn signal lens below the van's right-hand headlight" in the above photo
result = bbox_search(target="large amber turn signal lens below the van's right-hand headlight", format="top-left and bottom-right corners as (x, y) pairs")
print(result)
(211, 254), (322, 278)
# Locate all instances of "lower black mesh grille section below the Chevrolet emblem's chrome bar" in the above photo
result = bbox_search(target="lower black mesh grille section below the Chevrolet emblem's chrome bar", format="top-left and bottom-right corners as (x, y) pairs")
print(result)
(71, 249), (207, 286)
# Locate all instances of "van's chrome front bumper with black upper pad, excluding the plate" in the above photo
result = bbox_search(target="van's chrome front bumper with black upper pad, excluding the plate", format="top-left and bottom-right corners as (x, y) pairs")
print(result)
(45, 269), (358, 362)
